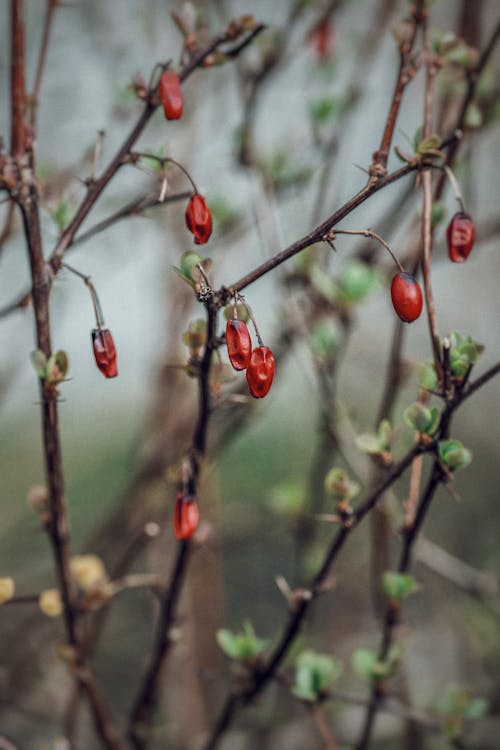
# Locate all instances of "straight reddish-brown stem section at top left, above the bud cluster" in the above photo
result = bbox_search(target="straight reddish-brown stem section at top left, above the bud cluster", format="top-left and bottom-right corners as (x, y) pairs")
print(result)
(10, 0), (26, 158)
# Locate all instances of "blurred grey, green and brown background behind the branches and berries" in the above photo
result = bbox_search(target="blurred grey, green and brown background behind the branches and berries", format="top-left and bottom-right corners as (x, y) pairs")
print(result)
(0, 0), (500, 750)
